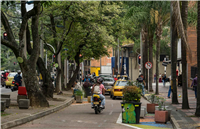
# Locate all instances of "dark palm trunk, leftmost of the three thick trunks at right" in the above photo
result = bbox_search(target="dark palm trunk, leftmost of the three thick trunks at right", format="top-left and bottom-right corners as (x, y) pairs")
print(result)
(171, 0), (178, 104)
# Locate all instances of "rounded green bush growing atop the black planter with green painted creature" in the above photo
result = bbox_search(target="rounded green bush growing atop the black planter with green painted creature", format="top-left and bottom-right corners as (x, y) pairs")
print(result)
(123, 86), (142, 102)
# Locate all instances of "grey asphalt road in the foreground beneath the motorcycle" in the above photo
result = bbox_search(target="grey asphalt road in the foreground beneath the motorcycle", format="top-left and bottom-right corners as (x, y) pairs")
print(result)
(13, 96), (134, 129)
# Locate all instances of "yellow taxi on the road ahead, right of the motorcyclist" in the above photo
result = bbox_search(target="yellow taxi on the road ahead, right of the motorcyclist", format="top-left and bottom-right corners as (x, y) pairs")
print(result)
(110, 79), (128, 99)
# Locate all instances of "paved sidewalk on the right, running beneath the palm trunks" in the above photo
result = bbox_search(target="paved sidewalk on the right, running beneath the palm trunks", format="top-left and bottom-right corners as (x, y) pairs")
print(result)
(147, 83), (200, 129)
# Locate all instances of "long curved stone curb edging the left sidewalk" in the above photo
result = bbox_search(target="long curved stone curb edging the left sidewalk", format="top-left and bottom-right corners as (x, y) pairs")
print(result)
(0, 98), (74, 129)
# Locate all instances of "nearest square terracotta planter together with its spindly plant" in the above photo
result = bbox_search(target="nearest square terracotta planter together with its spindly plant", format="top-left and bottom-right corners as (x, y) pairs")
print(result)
(155, 98), (168, 124)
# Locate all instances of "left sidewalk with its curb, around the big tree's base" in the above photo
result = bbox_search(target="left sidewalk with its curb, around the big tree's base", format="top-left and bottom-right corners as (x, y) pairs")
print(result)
(0, 90), (74, 129)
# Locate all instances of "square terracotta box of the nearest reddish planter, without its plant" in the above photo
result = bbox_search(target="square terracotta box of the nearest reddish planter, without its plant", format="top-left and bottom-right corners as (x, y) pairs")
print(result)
(155, 110), (168, 124)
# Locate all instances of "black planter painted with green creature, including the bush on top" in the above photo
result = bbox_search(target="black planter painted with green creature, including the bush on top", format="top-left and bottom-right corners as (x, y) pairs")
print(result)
(121, 82), (141, 124)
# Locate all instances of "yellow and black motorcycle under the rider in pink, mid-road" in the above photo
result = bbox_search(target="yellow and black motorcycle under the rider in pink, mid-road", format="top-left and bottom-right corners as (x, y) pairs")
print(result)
(93, 94), (103, 114)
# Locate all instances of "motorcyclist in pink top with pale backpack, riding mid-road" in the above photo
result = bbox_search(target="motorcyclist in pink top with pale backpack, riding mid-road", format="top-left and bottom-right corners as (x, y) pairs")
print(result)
(91, 78), (105, 109)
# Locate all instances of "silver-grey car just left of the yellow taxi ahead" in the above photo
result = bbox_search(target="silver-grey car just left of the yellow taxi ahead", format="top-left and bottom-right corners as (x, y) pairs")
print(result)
(103, 77), (115, 94)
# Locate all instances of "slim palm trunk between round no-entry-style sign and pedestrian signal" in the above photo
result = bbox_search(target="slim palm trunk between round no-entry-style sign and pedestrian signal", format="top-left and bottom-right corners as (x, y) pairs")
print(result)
(156, 17), (162, 95)
